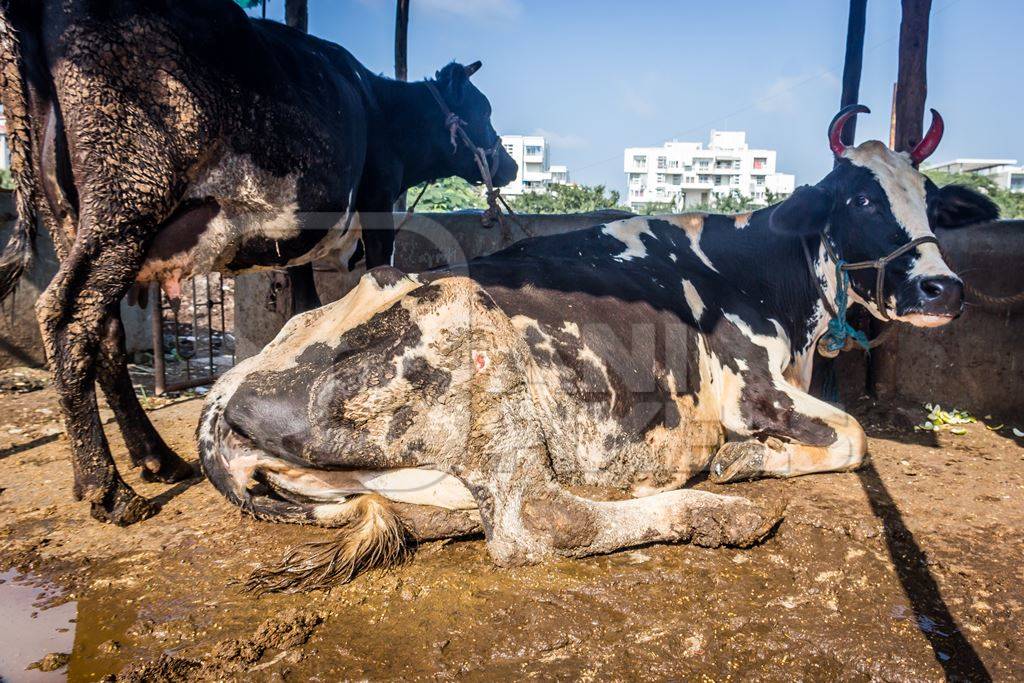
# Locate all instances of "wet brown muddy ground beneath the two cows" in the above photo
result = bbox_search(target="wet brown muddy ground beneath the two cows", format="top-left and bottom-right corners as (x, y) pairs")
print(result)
(0, 376), (1024, 681)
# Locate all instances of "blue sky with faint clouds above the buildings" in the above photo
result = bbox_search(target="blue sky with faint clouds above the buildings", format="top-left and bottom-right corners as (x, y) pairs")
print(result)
(245, 0), (1024, 197)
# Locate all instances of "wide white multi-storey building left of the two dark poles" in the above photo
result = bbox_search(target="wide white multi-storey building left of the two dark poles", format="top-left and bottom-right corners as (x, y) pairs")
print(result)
(624, 130), (795, 211)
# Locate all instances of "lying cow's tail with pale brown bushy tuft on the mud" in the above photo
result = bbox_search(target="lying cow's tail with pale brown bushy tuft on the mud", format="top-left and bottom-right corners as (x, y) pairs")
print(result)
(199, 364), (409, 595)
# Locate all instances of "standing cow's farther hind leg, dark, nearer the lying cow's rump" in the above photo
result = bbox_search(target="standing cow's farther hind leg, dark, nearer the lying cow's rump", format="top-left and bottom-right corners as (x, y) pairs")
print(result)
(97, 304), (196, 483)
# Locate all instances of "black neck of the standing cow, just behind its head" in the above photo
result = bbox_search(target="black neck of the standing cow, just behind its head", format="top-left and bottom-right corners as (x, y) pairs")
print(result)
(368, 77), (451, 193)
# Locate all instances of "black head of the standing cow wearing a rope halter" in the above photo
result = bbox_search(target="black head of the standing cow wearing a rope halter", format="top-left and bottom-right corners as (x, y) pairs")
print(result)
(434, 61), (519, 187)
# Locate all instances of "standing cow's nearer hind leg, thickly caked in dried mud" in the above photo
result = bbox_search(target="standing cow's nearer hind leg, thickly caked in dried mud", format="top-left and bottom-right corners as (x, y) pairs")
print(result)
(36, 242), (155, 525)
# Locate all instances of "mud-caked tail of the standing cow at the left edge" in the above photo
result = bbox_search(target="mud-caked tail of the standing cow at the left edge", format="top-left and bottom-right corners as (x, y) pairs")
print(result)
(0, 0), (38, 301)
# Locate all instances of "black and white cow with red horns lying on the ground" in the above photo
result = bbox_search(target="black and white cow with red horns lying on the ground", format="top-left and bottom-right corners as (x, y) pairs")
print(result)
(199, 105), (994, 589)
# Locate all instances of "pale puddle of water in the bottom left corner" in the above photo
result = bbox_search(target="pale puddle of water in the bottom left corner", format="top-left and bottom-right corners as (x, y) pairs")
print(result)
(0, 571), (77, 683)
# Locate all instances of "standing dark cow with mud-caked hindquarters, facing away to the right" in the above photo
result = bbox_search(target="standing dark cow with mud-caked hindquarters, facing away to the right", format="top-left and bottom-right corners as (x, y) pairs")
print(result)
(0, 0), (516, 524)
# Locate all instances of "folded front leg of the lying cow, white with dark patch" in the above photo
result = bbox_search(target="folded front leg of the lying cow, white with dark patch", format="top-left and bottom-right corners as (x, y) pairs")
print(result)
(710, 382), (867, 483)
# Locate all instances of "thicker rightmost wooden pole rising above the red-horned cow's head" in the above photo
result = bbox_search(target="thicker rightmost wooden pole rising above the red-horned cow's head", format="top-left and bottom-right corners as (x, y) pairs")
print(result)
(895, 0), (932, 152)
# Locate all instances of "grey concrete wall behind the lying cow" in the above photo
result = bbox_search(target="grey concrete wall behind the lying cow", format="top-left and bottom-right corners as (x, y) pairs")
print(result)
(236, 213), (1024, 416)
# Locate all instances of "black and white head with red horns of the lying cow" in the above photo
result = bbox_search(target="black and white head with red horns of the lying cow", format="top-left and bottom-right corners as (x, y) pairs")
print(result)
(770, 104), (998, 327)
